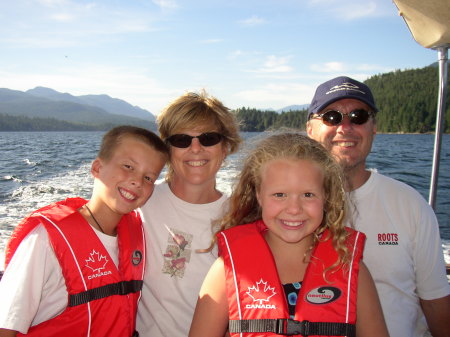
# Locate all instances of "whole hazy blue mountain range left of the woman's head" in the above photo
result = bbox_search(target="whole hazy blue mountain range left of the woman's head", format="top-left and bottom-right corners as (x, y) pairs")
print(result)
(0, 87), (156, 131)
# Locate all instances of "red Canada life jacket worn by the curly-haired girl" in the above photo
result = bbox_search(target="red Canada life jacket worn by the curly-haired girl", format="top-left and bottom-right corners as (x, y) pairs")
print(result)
(218, 220), (365, 337)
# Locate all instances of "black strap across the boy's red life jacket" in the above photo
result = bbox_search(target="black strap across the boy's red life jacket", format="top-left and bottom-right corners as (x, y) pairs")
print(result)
(69, 280), (144, 307)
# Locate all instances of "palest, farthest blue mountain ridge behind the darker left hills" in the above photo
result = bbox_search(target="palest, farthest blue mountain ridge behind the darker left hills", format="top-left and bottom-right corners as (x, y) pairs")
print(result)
(26, 87), (155, 121)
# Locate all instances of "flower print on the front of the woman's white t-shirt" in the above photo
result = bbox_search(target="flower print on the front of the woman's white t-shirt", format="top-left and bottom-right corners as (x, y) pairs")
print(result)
(162, 226), (192, 278)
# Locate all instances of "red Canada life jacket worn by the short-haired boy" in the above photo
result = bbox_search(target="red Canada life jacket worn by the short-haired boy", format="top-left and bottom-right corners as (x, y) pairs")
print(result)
(6, 198), (145, 337)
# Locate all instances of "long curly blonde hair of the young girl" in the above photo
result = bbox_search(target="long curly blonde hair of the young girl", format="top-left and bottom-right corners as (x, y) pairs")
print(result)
(215, 133), (348, 269)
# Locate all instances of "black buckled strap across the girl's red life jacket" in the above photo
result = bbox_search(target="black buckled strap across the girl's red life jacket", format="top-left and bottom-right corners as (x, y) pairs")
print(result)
(228, 318), (356, 337)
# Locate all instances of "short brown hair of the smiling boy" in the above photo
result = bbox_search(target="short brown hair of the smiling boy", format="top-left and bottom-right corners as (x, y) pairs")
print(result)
(97, 125), (169, 161)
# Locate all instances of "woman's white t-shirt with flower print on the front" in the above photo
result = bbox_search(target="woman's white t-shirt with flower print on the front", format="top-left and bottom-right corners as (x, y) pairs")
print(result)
(137, 182), (227, 337)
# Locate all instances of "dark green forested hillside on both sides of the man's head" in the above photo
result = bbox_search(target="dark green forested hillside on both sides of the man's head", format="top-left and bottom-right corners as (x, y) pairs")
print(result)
(236, 65), (450, 133)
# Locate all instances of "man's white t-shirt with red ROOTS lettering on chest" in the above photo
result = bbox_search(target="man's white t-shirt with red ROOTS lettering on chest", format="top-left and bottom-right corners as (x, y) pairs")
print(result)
(350, 172), (450, 337)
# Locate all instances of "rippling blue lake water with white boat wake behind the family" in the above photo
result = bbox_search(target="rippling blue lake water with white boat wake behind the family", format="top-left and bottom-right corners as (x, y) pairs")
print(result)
(0, 132), (450, 270)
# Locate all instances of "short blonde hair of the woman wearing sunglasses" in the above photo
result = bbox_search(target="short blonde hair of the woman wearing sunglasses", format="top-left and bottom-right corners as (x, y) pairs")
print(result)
(157, 90), (242, 181)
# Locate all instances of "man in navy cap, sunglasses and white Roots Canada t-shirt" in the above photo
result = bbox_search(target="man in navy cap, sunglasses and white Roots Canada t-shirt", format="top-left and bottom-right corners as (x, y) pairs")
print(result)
(306, 76), (450, 337)
